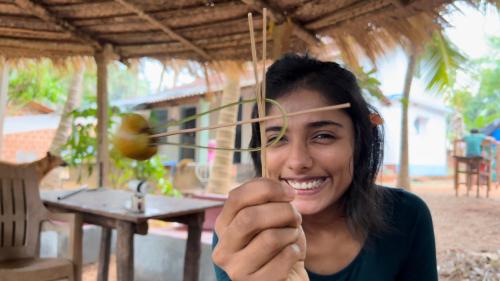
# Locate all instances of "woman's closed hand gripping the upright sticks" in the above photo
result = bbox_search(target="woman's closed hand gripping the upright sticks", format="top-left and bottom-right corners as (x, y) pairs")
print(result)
(212, 179), (309, 281)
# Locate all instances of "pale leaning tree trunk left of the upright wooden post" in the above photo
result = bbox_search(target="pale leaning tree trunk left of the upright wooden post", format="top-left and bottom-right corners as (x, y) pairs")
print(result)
(49, 62), (85, 155)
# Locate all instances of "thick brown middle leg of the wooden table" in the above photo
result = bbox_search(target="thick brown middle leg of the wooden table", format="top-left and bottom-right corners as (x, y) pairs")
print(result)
(116, 221), (134, 281)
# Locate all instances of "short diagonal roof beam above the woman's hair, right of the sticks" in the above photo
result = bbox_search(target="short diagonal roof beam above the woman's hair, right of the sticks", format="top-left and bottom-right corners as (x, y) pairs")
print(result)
(241, 0), (321, 46)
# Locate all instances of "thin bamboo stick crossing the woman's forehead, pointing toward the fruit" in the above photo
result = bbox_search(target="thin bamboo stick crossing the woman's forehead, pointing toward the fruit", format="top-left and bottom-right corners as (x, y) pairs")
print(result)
(149, 103), (351, 138)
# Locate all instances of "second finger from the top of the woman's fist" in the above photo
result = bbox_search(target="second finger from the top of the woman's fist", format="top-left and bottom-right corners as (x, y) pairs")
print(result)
(219, 203), (302, 252)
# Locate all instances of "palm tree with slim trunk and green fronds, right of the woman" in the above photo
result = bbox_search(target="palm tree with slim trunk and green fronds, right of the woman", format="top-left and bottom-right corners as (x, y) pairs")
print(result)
(397, 31), (465, 190)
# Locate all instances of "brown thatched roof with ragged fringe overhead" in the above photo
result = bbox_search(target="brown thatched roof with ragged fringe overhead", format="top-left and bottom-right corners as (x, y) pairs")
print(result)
(0, 0), (458, 61)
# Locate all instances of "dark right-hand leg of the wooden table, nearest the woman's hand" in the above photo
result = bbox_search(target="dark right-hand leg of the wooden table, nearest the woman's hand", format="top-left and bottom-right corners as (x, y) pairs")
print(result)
(183, 212), (205, 281)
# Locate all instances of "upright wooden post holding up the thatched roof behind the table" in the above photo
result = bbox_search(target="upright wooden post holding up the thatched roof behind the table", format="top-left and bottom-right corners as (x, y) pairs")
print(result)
(94, 45), (112, 187)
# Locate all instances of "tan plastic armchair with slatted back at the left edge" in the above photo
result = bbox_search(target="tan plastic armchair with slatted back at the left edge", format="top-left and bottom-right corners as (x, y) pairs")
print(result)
(0, 163), (82, 281)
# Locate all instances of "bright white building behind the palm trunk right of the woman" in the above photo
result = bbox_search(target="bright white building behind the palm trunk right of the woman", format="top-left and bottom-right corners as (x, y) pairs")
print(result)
(377, 92), (450, 176)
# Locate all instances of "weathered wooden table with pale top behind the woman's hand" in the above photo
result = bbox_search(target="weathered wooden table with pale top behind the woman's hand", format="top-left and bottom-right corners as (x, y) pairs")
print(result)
(41, 188), (223, 281)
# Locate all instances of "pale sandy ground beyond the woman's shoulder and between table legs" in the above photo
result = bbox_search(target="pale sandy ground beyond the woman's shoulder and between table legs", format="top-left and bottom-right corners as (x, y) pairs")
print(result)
(79, 178), (500, 281)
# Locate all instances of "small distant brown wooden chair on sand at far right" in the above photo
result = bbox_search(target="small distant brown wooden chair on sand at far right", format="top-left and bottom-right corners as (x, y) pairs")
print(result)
(453, 140), (491, 198)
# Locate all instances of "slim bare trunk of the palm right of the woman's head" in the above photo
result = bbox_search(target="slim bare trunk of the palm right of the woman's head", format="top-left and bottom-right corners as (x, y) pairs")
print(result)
(396, 52), (416, 190)
